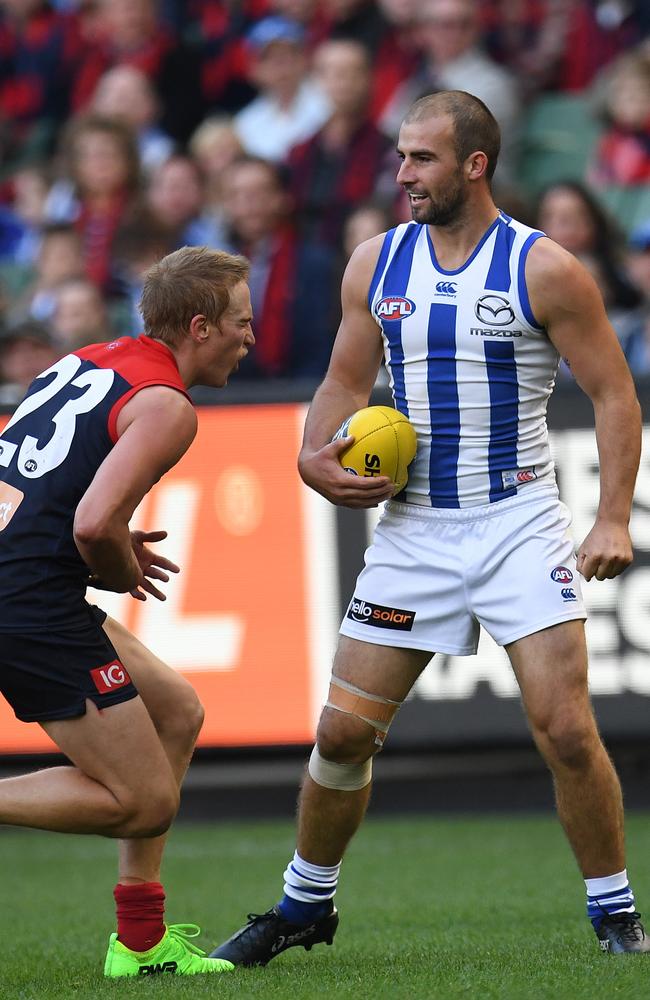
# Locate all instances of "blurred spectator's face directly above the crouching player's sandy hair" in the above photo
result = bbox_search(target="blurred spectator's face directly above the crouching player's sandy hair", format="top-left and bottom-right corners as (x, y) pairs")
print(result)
(146, 156), (222, 249)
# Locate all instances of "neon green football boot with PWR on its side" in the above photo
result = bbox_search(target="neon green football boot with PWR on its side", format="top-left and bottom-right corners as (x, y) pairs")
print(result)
(104, 924), (235, 979)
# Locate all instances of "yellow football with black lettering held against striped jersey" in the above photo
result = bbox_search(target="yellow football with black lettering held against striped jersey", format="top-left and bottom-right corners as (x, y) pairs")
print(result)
(332, 406), (417, 493)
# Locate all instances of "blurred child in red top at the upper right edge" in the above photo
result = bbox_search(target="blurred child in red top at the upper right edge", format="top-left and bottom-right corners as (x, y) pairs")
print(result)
(589, 51), (650, 185)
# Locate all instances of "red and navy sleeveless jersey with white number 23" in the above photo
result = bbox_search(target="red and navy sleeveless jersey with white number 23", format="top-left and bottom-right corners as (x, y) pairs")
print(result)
(0, 336), (190, 632)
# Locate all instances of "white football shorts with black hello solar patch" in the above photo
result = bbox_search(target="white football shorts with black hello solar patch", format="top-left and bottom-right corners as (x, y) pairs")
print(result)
(340, 487), (587, 656)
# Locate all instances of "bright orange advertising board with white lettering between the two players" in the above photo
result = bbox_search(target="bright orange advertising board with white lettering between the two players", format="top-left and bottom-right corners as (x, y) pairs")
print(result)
(0, 404), (338, 753)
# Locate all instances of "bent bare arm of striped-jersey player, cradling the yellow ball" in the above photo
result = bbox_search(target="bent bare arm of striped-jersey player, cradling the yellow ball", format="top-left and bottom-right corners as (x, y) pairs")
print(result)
(298, 236), (393, 507)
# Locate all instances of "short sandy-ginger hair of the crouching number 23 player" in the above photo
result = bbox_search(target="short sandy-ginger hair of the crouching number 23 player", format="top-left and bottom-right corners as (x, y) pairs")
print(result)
(140, 247), (249, 345)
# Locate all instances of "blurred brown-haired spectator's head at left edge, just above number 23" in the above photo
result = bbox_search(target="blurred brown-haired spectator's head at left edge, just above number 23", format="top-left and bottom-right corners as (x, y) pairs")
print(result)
(0, 320), (60, 406)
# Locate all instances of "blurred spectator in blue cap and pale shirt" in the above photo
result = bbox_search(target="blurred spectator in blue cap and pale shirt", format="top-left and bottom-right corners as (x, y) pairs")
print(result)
(235, 16), (330, 161)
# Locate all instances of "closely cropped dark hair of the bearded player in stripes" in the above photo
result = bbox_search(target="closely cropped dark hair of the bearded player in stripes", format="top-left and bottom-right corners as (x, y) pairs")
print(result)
(404, 90), (501, 181)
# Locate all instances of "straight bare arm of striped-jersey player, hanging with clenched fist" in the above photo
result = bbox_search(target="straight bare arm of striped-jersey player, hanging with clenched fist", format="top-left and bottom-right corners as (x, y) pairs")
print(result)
(526, 239), (641, 580)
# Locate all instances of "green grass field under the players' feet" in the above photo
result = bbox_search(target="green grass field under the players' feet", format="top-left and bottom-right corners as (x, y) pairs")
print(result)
(5, 814), (650, 1000)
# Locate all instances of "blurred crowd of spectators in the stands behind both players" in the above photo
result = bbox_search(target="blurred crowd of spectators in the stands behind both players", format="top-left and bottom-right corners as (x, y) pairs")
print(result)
(0, 0), (650, 405)
